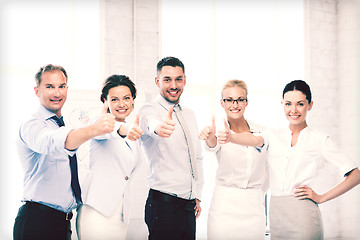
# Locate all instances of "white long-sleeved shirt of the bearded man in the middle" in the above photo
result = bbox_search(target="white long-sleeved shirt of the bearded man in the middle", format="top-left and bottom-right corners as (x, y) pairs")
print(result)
(139, 96), (204, 199)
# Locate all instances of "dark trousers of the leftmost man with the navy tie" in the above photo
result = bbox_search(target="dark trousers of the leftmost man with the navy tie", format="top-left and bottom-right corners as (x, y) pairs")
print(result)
(13, 202), (72, 240)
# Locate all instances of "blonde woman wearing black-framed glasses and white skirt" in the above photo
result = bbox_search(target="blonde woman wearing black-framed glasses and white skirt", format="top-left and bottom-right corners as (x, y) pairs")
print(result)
(199, 80), (266, 240)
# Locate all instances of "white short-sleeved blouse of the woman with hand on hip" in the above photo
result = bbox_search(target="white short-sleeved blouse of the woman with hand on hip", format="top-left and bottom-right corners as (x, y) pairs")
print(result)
(264, 127), (358, 196)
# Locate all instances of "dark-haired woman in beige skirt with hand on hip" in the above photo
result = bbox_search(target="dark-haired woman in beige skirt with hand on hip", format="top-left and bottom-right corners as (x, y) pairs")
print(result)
(218, 80), (360, 240)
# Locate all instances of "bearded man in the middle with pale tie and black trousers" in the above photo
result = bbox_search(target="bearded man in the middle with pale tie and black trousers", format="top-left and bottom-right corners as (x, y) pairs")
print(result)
(139, 57), (203, 239)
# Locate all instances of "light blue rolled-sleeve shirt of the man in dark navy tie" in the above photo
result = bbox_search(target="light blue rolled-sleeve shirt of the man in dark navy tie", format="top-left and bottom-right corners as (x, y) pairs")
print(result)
(17, 106), (77, 212)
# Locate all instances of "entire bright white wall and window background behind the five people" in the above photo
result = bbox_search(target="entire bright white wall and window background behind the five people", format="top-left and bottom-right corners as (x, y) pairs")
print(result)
(0, 0), (360, 239)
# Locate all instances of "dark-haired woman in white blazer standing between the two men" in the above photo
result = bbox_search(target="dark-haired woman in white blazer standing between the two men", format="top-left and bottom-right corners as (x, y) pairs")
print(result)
(77, 75), (142, 239)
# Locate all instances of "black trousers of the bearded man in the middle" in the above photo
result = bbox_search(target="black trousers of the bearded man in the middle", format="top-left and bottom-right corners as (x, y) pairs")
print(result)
(145, 189), (196, 240)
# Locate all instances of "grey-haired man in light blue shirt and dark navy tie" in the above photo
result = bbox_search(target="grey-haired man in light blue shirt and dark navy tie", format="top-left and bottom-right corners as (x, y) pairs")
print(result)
(13, 64), (115, 240)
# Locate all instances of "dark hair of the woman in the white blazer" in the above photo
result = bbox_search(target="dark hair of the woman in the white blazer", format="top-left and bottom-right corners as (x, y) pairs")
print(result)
(100, 74), (136, 102)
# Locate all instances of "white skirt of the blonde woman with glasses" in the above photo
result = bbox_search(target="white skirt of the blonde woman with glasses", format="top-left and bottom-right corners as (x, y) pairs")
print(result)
(207, 185), (266, 240)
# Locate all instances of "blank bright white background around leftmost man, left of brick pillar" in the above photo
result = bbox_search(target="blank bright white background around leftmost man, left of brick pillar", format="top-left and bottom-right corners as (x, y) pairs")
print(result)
(0, 0), (99, 239)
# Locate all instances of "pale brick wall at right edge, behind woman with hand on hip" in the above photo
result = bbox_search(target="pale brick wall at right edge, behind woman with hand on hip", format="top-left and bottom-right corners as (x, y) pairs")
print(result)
(304, 0), (360, 239)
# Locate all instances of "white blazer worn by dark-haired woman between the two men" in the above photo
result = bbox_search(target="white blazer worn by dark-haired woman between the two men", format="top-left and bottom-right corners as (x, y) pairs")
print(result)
(82, 122), (142, 223)
